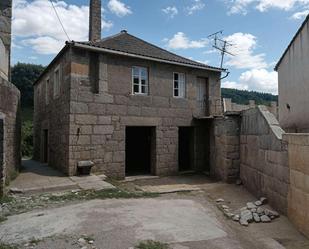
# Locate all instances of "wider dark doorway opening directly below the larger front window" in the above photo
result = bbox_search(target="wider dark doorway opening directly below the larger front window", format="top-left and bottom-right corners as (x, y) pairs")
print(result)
(126, 127), (155, 176)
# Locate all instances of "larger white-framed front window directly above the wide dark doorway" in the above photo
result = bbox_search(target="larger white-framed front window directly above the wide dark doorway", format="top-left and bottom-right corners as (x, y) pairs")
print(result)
(132, 67), (148, 95)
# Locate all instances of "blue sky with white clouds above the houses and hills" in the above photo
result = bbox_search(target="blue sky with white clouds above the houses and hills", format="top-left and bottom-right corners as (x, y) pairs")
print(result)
(12, 0), (309, 94)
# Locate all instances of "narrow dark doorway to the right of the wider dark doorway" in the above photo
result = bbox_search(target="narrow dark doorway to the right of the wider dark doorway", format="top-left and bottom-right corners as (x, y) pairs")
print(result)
(178, 127), (194, 171)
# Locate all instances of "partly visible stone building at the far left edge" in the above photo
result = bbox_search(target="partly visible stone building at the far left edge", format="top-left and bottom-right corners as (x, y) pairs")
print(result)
(0, 0), (20, 196)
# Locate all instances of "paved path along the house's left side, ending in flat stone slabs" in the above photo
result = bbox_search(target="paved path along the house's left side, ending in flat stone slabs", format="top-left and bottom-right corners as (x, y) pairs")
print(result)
(10, 160), (113, 193)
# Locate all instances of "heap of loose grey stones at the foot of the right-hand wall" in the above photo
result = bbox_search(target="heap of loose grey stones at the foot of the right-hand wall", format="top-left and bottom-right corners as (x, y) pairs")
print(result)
(216, 197), (280, 226)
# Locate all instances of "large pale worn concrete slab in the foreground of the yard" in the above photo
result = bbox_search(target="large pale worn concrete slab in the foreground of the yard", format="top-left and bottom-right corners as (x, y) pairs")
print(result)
(0, 199), (226, 245)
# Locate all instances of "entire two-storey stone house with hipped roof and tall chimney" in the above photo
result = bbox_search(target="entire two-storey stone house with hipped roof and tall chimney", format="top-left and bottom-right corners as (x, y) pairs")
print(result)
(34, 0), (224, 178)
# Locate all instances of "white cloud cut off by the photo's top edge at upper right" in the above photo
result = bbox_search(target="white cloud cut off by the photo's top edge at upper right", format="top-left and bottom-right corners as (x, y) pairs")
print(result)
(226, 0), (309, 15)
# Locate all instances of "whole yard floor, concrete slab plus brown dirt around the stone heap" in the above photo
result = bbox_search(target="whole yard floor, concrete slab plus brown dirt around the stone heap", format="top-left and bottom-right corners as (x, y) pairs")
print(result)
(0, 176), (309, 249)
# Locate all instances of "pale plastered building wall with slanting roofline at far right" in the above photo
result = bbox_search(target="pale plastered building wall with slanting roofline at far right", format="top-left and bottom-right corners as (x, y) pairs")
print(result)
(275, 15), (309, 133)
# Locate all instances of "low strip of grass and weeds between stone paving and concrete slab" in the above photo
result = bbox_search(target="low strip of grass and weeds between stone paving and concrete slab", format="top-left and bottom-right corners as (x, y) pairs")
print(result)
(49, 189), (159, 201)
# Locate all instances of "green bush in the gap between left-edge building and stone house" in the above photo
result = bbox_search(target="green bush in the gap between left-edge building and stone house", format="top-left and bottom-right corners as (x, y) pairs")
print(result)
(21, 120), (33, 157)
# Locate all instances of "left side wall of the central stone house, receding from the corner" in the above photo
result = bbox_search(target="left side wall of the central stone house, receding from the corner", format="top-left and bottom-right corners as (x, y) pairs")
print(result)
(33, 50), (72, 174)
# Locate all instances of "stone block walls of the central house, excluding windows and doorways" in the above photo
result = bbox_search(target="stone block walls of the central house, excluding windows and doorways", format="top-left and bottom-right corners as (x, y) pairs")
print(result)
(34, 48), (222, 178)
